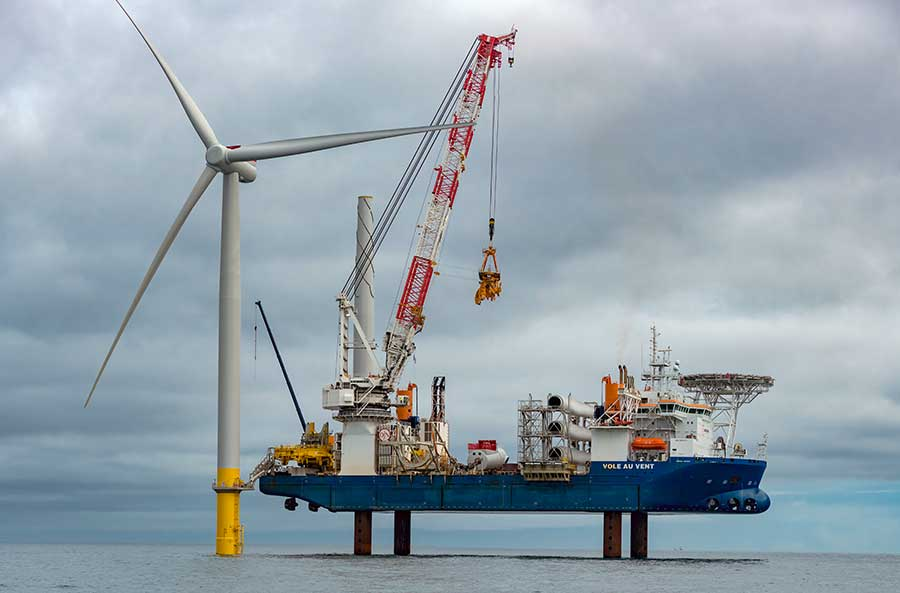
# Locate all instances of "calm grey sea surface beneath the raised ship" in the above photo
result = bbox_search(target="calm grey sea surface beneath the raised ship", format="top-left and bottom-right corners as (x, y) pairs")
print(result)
(0, 544), (900, 593)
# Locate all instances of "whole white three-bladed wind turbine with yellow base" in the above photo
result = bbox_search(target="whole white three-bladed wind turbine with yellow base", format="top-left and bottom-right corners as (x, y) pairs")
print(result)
(84, 0), (471, 556)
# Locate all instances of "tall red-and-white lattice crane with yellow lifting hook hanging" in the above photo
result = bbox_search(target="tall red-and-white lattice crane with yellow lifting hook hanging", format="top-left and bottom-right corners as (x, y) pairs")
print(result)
(322, 28), (516, 442)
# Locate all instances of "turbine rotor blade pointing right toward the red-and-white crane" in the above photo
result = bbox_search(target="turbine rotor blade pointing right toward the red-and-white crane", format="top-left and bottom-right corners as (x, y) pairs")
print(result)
(225, 122), (475, 163)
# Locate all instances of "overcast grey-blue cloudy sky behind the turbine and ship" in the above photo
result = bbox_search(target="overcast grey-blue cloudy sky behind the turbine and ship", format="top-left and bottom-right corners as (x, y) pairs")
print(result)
(0, 0), (900, 551)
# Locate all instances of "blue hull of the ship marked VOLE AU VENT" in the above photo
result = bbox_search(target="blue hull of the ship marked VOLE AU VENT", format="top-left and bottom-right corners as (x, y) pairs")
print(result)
(259, 458), (770, 514)
